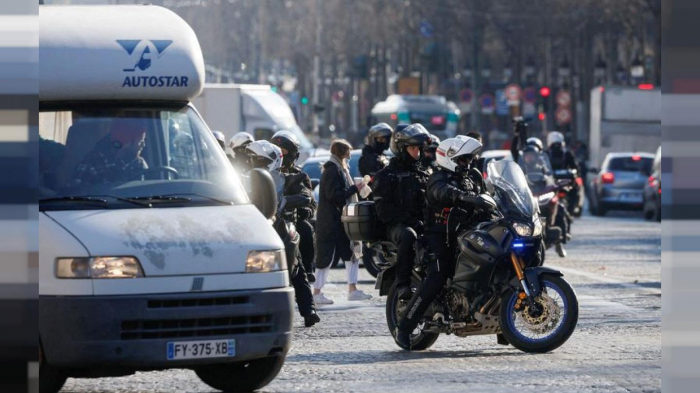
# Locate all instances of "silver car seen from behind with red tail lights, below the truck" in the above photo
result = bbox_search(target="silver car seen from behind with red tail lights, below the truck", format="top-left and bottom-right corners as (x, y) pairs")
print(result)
(589, 153), (654, 216)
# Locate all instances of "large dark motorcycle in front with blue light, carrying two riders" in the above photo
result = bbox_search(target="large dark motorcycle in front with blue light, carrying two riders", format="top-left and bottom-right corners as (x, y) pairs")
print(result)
(346, 159), (578, 353)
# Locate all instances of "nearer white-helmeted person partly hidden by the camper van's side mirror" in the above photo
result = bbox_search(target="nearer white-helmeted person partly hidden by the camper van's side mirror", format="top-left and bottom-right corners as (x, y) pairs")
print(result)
(246, 141), (321, 327)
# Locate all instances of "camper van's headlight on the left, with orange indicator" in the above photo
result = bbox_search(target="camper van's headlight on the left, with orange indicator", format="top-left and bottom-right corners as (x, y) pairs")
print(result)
(56, 257), (143, 279)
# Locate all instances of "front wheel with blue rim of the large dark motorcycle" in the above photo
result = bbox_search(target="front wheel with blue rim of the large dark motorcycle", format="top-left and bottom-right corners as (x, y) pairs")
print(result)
(499, 274), (578, 353)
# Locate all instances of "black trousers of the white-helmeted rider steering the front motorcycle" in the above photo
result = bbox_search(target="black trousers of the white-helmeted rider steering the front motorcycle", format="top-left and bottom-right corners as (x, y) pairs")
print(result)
(399, 232), (455, 333)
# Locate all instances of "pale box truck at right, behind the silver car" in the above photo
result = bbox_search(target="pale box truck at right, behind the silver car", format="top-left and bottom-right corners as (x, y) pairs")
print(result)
(588, 85), (661, 168)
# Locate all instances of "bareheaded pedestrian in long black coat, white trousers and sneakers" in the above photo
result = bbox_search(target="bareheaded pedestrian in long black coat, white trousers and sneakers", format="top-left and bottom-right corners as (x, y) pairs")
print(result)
(314, 139), (372, 305)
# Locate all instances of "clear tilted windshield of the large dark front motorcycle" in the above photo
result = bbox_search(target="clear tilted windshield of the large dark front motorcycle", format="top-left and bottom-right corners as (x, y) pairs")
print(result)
(487, 159), (537, 219)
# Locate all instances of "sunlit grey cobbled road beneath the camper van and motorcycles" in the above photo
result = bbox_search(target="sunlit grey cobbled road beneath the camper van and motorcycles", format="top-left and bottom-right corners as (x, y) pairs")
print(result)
(63, 212), (661, 393)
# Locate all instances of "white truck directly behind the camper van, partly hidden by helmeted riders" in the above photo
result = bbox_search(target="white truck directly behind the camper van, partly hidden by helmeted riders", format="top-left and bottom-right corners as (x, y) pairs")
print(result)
(192, 83), (327, 163)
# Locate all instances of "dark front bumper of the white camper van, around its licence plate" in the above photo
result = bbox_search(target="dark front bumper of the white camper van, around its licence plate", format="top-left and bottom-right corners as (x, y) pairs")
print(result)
(39, 287), (294, 370)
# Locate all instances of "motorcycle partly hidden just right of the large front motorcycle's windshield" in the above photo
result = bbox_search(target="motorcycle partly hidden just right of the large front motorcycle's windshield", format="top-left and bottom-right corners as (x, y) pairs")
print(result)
(518, 147), (571, 257)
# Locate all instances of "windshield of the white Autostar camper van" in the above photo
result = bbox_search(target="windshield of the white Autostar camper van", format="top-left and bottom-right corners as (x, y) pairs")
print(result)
(39, 105), (248, 210)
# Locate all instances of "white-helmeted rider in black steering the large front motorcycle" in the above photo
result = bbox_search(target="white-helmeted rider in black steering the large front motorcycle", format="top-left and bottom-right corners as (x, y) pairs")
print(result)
(394, 137), (495, 350)
